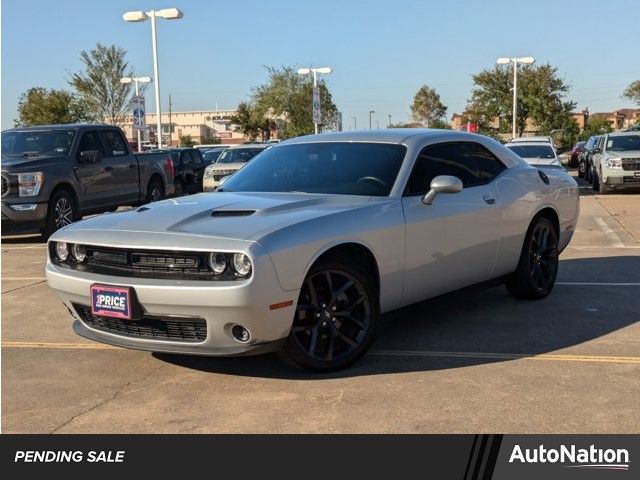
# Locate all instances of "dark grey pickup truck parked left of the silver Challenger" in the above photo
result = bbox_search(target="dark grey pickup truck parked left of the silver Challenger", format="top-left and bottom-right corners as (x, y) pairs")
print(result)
(2, 124), (174, 238)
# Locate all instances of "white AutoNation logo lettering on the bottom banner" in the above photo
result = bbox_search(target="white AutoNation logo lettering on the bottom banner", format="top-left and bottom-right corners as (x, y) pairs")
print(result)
(509, 444), (630, 470)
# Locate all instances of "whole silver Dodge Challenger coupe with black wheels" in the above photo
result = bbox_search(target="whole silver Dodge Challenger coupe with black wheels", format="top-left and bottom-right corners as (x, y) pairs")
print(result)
(46, 129), (579, 371)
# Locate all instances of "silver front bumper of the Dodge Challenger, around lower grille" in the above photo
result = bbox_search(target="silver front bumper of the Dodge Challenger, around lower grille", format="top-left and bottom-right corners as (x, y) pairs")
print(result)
(46, 251), (298, 356)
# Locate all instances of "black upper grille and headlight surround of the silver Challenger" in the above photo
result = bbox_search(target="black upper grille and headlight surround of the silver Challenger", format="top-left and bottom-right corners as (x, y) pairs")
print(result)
(49, 243), (241, 280)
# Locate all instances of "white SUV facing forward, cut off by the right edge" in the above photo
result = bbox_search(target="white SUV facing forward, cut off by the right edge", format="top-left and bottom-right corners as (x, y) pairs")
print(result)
(592, 131), (640, 194)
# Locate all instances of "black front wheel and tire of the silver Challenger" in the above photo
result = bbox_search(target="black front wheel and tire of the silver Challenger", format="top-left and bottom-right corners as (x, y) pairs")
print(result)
(281, 258), (380, 372)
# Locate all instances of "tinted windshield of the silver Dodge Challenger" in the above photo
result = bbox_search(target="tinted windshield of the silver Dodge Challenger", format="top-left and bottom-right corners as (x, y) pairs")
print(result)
(223, 142), (407, 196)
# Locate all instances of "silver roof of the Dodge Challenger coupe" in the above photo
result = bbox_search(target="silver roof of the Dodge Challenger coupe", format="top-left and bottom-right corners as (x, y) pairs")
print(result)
(274, 128), (479, 147)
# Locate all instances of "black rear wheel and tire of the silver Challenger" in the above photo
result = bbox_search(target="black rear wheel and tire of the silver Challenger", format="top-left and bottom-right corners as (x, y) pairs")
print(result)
(506, 217), (558, 300)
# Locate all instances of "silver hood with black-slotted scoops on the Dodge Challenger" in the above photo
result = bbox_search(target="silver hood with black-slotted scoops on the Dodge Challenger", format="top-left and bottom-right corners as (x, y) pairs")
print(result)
(52, 192), (372, 247)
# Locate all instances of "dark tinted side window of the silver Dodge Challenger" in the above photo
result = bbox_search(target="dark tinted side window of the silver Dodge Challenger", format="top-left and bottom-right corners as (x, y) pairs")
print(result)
(405, 142), (505, 195)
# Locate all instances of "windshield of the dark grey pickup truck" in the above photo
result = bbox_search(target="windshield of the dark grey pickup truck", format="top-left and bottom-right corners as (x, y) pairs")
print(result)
(2, 129), (76, 156)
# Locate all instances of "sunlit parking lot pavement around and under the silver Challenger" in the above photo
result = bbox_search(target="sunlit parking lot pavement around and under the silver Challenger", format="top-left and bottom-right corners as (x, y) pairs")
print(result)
(2, 174), (640, 433)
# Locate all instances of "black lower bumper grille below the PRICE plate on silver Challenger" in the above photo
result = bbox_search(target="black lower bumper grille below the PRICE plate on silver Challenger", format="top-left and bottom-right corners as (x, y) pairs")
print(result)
(73, 304), (207, 343)
